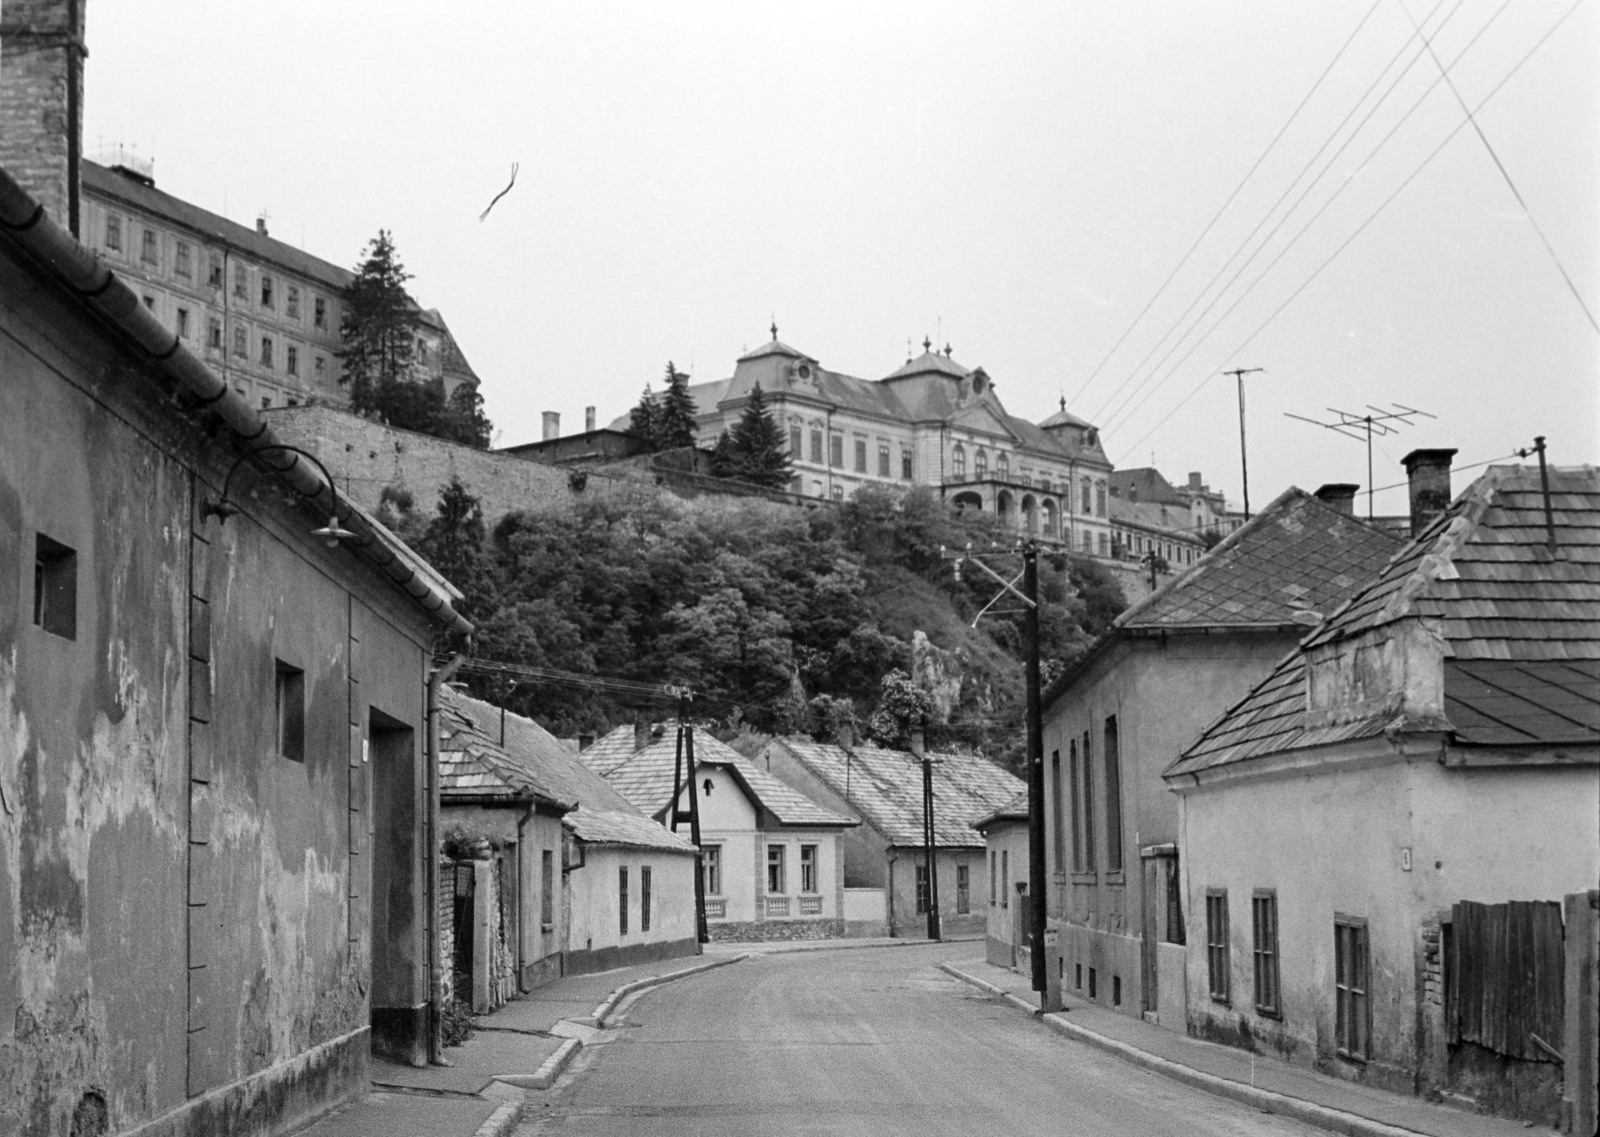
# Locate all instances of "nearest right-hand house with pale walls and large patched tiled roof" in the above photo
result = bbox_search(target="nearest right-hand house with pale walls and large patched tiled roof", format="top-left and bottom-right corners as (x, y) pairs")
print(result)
(1165, 465), (1600, 1121)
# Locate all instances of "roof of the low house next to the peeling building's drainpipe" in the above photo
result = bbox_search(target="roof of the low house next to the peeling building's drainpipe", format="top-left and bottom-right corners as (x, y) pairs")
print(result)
(440, 688), (694, 852)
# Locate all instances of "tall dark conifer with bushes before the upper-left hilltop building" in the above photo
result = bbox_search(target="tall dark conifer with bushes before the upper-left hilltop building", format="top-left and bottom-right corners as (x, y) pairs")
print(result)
(339, 229), (493, 449)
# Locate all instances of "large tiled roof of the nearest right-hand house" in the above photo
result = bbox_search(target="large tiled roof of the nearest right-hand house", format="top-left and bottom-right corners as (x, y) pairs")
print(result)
(1166, 467), (1600, 777)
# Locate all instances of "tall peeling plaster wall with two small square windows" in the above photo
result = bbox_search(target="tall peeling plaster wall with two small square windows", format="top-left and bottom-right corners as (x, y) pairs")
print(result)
(0, 244), (429, 1137)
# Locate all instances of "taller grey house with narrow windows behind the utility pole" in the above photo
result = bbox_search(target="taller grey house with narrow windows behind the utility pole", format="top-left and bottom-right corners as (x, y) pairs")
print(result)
(1043, 488), (1400, 1028)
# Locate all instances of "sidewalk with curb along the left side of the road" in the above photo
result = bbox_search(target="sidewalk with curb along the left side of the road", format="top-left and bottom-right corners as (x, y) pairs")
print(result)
(296, 951), (746, 1137)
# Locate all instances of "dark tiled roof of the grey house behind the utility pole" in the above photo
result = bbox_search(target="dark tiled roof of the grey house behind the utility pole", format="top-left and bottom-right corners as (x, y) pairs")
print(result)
(1117, 486), (1402, 630)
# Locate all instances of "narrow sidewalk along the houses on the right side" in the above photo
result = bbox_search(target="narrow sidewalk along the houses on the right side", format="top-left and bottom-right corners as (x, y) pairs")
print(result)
(941, 959), (1528, 1137)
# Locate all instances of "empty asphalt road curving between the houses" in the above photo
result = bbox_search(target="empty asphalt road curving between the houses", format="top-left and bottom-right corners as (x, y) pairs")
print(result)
(518, 945), (1322, 1137)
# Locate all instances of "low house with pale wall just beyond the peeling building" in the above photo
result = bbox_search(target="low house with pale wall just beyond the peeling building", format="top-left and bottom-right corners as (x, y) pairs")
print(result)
(440, 691), (699, 985)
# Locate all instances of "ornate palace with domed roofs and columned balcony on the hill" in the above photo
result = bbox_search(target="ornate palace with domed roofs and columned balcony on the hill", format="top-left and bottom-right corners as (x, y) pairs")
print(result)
(613, 326), (1112, 557)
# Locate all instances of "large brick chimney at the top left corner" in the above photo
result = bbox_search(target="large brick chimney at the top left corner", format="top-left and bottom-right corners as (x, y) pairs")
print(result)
(0, 0), (88, 237)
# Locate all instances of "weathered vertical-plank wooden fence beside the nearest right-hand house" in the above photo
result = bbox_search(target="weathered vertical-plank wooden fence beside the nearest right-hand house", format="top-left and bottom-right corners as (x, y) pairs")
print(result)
(1445, 900), (1565, 1062)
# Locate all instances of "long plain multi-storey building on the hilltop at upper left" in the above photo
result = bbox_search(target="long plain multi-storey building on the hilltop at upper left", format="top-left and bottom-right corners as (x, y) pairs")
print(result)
(80, 157), (478, 406)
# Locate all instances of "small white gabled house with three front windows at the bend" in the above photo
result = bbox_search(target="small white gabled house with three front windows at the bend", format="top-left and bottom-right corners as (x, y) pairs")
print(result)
(581, 728), (858, 940)
